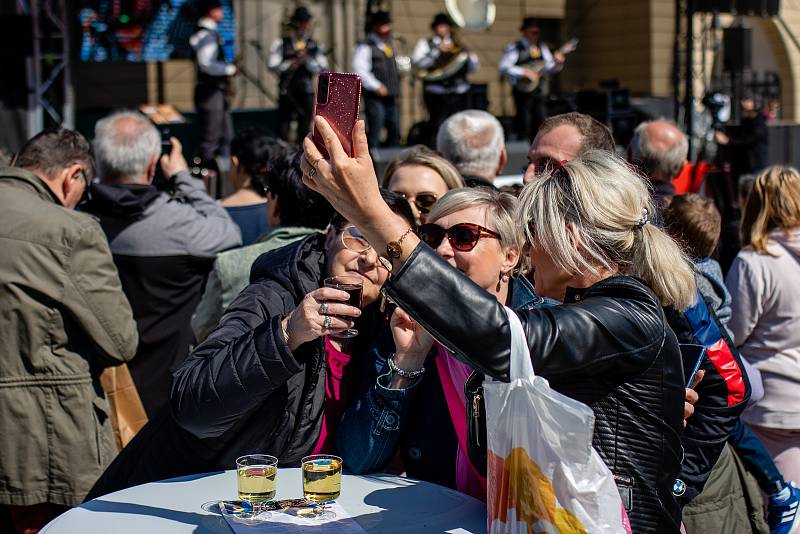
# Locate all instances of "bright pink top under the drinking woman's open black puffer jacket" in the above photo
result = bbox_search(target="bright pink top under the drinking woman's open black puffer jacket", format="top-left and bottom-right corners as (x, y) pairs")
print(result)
(312, 336), (352, 454)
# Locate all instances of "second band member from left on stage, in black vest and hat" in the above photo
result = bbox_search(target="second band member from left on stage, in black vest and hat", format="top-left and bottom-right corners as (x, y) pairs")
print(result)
(269, 6), (328, 141)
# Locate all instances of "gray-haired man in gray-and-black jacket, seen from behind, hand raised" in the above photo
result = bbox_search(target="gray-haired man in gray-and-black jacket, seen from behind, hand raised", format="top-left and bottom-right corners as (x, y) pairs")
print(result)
(85, 111), (241, 417)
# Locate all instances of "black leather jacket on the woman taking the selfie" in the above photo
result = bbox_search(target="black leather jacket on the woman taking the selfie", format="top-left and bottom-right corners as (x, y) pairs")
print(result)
(387, 244), (684, 534)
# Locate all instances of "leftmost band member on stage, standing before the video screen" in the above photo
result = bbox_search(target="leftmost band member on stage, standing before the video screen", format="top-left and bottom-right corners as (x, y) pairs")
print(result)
(189, 0), (236, 167)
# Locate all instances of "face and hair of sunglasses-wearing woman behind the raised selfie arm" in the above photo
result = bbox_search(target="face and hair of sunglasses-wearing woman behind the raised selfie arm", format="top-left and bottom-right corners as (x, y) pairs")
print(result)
(381, 145), (464, 226)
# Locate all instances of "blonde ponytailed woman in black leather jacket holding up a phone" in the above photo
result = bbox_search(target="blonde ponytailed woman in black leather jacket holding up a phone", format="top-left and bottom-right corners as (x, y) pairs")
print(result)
(303, 117), (695, 533)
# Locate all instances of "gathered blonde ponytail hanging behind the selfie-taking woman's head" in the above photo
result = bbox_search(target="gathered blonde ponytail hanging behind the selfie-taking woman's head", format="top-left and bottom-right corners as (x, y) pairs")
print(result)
(627, 224), (697, 311)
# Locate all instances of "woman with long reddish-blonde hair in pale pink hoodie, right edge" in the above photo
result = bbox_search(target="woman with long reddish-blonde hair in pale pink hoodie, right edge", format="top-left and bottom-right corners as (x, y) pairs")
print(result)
(725, 166), (800, 494)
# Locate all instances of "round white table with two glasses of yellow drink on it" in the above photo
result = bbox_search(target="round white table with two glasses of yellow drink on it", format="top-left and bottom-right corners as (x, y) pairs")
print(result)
(40, 468), (486, 534)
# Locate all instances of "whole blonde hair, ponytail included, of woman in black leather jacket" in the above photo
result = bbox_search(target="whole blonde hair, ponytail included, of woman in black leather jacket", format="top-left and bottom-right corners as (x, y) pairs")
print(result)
(517, 150), (695, 310)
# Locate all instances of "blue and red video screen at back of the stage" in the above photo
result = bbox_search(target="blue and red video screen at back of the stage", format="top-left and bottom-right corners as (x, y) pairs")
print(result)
(76, 0), (236, 62)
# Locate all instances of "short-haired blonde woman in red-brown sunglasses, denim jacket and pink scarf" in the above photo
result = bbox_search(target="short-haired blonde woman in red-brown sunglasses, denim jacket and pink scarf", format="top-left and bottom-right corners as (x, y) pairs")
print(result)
(337, 187), (556, 500)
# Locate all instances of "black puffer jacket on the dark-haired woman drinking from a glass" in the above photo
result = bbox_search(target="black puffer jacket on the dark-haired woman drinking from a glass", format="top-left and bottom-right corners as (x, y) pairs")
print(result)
(88, 234), (378, 498)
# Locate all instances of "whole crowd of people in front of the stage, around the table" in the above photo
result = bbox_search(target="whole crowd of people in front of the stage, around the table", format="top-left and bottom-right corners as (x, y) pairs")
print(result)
(0, 101), (800, 534)
